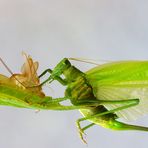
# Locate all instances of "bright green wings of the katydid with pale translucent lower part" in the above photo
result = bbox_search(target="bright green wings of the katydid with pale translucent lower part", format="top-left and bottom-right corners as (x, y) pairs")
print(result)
(86, 61), (148, 120)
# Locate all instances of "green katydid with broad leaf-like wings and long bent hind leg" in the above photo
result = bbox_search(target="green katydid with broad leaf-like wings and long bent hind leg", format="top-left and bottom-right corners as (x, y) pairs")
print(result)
(42, 58), (148, 142)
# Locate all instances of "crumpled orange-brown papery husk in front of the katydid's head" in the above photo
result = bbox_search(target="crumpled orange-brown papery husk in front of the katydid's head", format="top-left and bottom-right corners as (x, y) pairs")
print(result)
(10, 53), (45, 97)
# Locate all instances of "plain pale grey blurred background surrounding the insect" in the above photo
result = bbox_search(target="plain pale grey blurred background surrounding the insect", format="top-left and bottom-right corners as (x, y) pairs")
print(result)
(0, 0), (148, 148)
